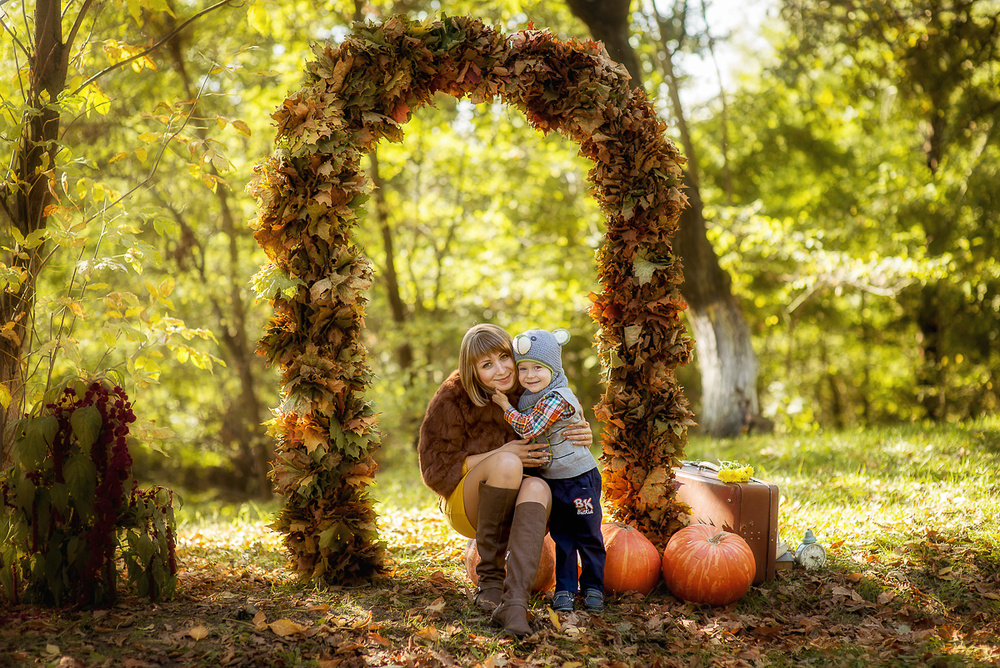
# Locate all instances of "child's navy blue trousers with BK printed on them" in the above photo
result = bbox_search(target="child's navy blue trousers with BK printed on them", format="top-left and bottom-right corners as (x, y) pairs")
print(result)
(546, 468), (607, 593)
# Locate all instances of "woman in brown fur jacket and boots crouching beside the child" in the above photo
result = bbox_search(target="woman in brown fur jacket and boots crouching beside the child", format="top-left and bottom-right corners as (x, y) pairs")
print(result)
(418, 324), (594, 637)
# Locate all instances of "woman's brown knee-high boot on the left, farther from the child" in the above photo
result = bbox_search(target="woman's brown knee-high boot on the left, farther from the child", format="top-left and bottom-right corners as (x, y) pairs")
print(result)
(475, 482), (518, 612)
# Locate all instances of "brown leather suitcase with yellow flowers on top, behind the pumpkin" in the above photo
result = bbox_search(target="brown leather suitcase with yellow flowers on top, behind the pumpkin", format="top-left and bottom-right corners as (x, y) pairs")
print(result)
(674, 462), (778, 584)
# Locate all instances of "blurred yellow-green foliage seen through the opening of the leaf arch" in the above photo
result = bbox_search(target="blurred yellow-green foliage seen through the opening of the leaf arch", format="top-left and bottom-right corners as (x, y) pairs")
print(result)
(357, 94), (604, 466)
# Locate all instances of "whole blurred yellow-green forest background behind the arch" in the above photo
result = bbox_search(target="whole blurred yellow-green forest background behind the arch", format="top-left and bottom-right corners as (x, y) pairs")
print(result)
(0, 0), (1000, 495)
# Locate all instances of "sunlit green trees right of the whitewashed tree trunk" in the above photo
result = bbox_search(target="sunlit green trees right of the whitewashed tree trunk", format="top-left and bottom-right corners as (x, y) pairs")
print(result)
(672, 2), (1000, 431)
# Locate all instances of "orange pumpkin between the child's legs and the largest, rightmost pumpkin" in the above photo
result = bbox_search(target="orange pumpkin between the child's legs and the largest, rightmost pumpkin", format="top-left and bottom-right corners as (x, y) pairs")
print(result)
(601, 522), (660, 595)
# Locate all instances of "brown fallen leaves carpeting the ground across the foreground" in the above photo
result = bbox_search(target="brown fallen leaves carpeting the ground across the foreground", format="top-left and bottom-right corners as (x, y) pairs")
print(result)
(0, 515), (1000, 668)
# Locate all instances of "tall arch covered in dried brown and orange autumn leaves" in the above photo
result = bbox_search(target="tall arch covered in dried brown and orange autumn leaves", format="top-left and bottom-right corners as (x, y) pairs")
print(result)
(249, 17), (694, 582)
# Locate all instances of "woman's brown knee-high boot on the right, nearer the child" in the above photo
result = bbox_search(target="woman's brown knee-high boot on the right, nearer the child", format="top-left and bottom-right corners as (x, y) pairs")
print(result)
(493, 502), (549, 638)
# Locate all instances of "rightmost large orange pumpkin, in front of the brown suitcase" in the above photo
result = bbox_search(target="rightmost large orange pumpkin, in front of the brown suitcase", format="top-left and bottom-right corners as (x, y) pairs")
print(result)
(663, 524), (757, 605)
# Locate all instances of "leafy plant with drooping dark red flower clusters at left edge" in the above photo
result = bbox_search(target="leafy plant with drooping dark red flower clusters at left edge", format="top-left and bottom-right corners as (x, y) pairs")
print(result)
(0, 379), (177, 605)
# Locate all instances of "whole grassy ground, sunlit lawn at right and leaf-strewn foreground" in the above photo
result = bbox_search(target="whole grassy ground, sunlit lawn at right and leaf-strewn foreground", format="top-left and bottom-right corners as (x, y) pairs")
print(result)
(0, 418), (1000, 668)
